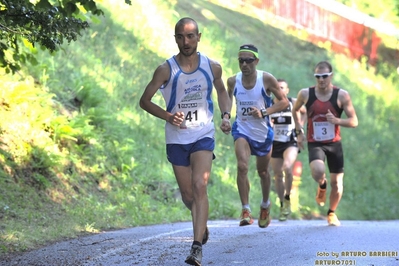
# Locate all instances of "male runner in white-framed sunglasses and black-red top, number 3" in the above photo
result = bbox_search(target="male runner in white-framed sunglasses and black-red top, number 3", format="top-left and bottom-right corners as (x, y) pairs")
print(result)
(292, 61), (358, 226)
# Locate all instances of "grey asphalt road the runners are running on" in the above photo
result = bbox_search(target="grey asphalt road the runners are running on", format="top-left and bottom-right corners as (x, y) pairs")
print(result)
(0, 220), (399, 266)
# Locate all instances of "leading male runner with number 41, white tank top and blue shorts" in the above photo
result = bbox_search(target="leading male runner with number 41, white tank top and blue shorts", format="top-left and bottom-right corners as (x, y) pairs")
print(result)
(140, 17), (231, 265)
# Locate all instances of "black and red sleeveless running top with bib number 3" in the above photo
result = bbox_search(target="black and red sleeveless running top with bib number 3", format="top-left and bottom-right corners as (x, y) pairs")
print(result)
(305, 86), (343, 143)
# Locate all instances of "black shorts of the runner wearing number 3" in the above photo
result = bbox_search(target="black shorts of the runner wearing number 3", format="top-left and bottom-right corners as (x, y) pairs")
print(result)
(308, 141), (344, 174)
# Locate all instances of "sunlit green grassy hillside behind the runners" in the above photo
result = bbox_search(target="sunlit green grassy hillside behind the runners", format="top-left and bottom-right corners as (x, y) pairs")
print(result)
(0, 0), (399, 255)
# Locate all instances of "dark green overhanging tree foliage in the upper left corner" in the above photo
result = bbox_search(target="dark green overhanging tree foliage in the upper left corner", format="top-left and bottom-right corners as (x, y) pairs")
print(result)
(0, 0), (130, 73)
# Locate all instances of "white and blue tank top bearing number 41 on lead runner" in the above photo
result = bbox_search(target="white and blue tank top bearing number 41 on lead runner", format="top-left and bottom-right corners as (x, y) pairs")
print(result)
(160, 53), (215, 144)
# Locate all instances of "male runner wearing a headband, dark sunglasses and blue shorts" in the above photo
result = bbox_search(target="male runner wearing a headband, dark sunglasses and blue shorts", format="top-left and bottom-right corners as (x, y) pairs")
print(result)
(227, 44), (288, 228)
